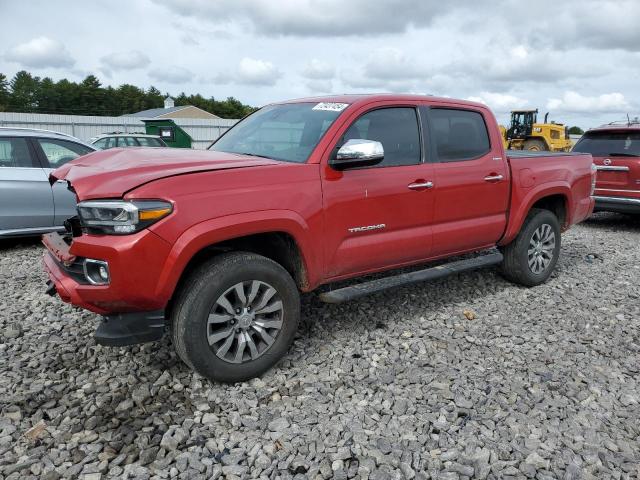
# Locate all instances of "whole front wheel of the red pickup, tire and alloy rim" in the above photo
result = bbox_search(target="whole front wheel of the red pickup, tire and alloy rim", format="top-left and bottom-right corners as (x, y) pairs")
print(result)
(170, 252), (300, 382)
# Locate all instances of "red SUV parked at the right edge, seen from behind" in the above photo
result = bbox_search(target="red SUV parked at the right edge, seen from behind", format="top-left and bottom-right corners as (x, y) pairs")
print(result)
(573, 120), (640, 214)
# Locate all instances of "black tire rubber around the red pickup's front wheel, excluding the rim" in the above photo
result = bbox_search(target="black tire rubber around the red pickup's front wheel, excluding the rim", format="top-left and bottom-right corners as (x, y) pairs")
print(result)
(176, 254), (300, 382)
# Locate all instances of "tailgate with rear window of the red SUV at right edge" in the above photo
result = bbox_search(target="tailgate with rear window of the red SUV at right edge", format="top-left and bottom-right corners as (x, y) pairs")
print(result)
(573, 128), (640, 198)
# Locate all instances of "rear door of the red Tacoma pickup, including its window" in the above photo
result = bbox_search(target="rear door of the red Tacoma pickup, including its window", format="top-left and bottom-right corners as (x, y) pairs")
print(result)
(424, 107), (510, 256)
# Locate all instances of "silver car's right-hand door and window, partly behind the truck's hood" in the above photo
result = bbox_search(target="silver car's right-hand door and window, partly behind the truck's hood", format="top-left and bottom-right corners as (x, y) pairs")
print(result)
(35, 138), (94, 226)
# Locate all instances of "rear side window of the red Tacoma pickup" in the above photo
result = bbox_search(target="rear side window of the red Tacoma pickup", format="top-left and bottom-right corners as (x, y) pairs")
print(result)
(429, 108), (491, 162)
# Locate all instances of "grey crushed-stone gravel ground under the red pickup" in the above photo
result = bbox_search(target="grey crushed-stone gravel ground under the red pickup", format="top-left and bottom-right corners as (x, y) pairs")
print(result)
(0, 214), (640, 479)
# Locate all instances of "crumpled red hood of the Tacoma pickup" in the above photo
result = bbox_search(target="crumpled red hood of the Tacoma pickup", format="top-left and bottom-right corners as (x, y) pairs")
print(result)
(50, 148), (281, 200)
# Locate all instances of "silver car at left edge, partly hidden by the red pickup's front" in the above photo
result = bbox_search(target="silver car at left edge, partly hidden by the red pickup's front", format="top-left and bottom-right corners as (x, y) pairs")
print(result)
(0, 128), (96, 238)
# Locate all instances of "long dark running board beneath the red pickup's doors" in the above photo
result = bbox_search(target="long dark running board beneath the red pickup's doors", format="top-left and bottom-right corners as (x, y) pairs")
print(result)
(319, 252), (502, 303)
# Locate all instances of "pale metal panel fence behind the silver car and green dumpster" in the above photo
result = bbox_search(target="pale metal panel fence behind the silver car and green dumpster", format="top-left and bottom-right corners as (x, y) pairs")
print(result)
(0, 112), (237, 149)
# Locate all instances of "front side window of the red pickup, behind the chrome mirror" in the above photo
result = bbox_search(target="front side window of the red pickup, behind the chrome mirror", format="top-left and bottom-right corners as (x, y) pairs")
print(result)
(343, 107), (420, 167)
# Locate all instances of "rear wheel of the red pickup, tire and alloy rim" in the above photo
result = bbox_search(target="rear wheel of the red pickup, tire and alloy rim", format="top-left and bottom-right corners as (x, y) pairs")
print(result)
(500, 208), (561, 287)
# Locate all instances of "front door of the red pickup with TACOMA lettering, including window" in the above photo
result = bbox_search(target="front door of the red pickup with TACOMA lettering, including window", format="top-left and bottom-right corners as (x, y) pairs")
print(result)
(322, 107), (433, 278)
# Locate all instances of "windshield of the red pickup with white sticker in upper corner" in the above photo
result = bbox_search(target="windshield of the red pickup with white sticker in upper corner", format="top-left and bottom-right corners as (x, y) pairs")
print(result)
(209, 103), (347, 163)
